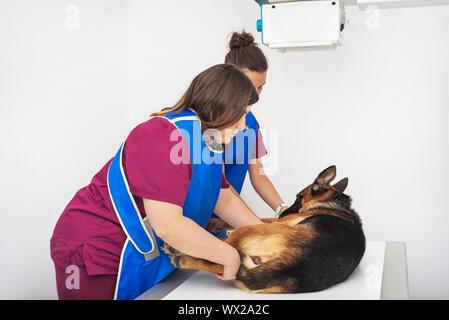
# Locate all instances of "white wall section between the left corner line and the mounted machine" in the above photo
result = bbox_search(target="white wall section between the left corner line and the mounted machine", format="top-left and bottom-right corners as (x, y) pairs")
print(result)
(128, 0), (258, 124)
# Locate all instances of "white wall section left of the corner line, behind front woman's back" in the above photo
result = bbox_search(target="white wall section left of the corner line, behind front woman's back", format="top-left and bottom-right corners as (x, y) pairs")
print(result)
(0, 0), (129, 299)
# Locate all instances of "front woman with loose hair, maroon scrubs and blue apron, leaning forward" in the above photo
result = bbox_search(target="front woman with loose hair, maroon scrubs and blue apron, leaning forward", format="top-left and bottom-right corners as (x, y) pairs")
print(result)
(50, 64), (261, 299)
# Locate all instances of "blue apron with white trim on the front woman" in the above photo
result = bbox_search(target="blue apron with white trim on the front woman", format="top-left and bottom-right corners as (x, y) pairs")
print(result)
(108, 110), (223, 300)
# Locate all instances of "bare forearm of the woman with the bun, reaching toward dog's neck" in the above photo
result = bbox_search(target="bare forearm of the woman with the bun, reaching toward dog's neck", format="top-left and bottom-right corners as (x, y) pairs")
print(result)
(248, 158), (288, 213)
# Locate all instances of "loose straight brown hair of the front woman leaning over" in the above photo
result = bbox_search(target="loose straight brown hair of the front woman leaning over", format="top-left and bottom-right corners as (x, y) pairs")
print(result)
(151, 64), (259, 130)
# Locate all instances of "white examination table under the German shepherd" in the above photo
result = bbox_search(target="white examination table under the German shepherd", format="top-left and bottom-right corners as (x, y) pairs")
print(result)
(137, 241), (408, 300)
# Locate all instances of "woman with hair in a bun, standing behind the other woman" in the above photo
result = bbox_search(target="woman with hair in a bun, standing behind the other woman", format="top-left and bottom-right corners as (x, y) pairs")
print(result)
(221, 31), (288, 216)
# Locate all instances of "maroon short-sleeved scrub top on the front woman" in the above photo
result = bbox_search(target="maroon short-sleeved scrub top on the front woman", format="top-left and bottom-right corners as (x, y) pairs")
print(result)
(50, 117), (234, 276)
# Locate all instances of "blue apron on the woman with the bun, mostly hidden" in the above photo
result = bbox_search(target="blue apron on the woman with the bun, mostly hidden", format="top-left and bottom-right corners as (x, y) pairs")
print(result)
(212, 111), (259, 238)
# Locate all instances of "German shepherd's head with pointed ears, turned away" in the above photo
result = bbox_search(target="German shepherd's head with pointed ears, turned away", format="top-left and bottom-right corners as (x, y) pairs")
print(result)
(280, 166), (350, 218)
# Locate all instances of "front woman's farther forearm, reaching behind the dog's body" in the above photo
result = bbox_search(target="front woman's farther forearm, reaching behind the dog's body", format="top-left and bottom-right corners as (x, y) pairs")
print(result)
(214, 185), (263, 228)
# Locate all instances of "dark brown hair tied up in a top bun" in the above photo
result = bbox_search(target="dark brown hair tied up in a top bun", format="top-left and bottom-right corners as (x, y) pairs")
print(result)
(225, 30), (268, 72)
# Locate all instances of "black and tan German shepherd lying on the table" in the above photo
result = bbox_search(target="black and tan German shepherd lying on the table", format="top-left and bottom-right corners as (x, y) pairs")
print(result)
(162, 166), (366, 293)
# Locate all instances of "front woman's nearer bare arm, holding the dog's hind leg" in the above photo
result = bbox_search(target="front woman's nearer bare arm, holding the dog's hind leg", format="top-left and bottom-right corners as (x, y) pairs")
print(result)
(143, 198), (240, 280)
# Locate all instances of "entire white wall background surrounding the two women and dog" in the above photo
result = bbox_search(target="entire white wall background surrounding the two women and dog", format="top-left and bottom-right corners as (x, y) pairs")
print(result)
(0, 0), (449, 299)
